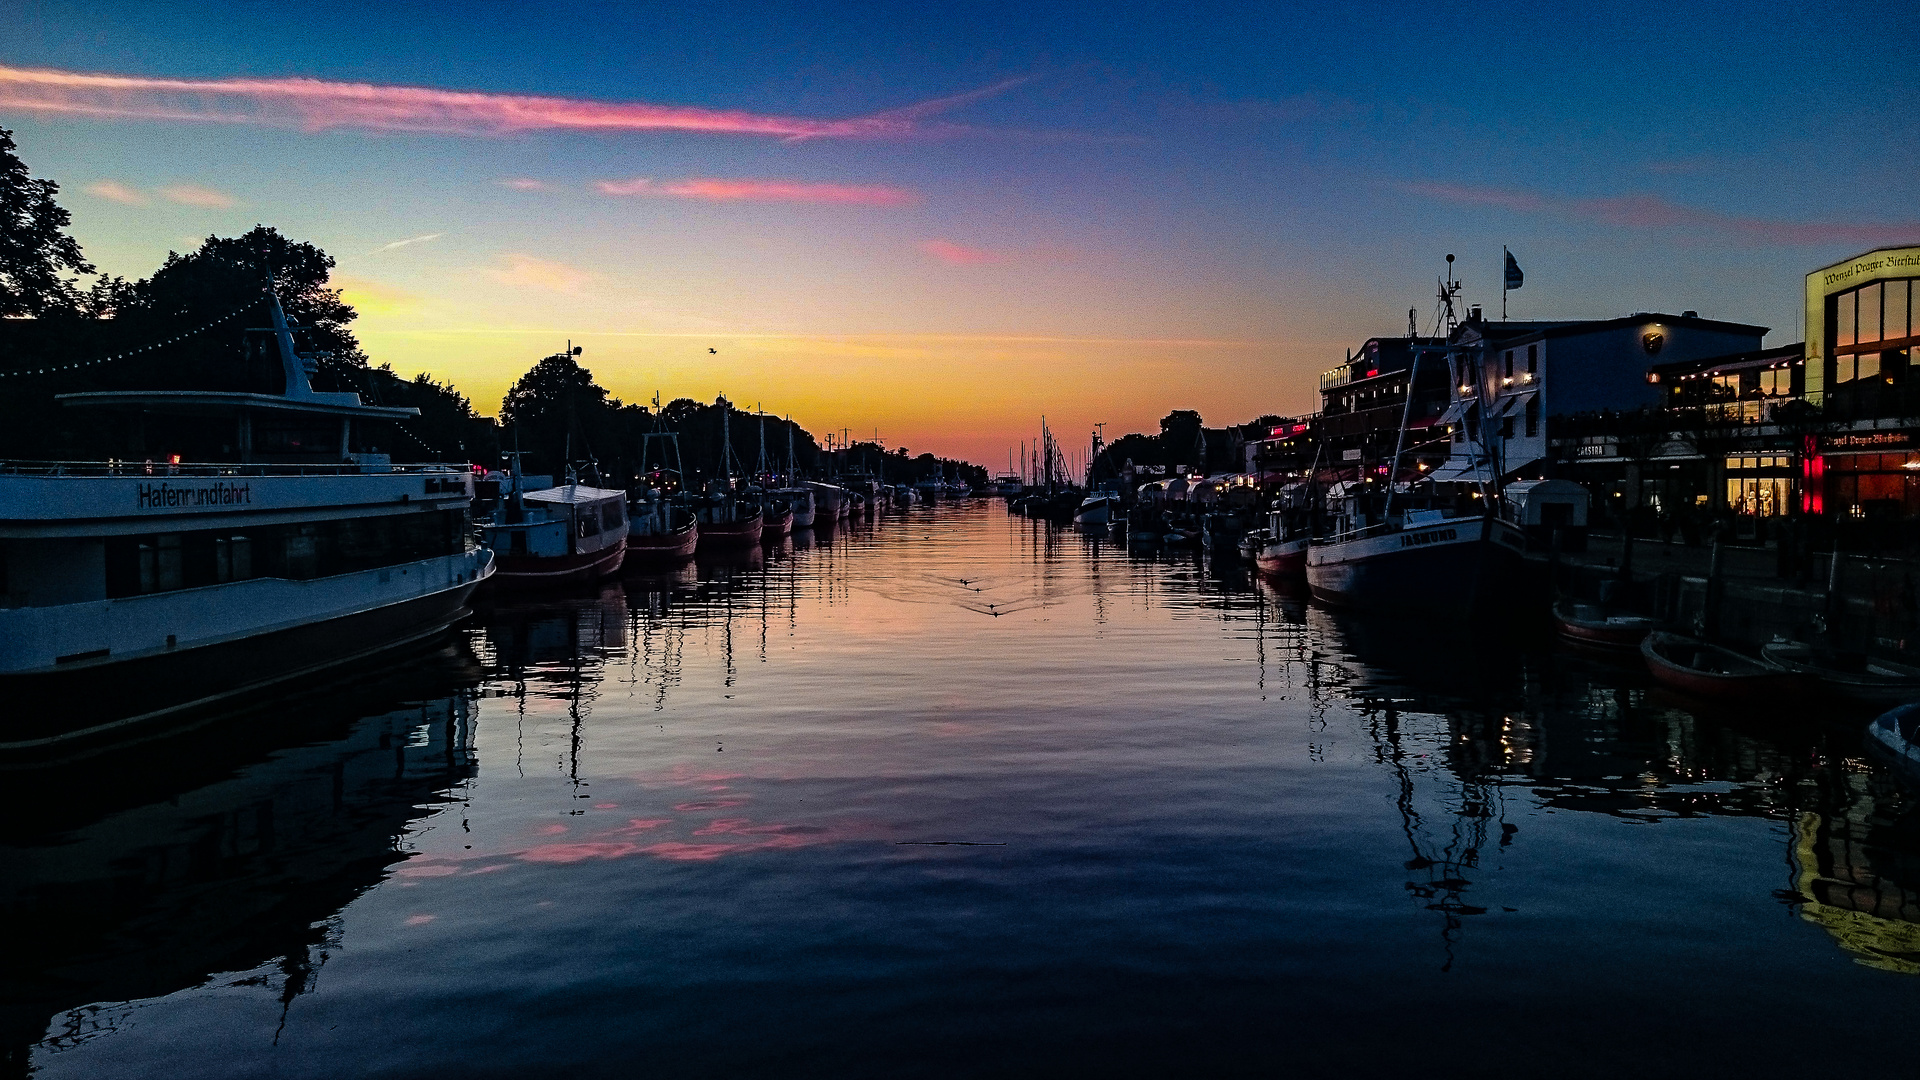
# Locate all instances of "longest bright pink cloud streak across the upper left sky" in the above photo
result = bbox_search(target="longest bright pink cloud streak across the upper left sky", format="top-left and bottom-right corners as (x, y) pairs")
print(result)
(0, 65), (1020, 138)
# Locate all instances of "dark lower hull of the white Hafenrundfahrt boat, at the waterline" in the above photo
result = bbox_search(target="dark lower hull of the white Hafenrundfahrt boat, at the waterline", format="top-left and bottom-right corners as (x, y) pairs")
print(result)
(0, 557), (497, 757)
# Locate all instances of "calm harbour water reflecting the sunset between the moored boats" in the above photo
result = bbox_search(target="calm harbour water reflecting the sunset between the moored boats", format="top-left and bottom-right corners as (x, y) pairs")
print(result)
(0, 502), (1920, 1078)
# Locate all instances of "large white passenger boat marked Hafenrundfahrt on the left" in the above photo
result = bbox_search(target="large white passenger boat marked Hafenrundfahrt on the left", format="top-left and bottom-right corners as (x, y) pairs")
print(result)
(0, 282), (493, 751)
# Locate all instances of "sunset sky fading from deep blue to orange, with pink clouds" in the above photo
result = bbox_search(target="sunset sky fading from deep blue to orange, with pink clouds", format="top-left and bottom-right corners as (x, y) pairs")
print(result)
(0, 0), (1920, 467)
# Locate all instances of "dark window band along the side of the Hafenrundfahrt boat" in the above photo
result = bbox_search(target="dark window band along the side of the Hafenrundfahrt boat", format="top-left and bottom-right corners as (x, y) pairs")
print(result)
(106, 509), (467, 598)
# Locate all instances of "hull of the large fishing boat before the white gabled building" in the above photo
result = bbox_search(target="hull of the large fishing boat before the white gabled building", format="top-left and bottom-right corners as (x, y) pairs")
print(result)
(1306, 517), (1526, 609)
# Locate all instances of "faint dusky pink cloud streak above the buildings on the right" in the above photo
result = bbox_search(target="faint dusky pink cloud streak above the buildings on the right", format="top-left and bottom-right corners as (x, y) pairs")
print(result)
(1404, 184), (1920, 244)
